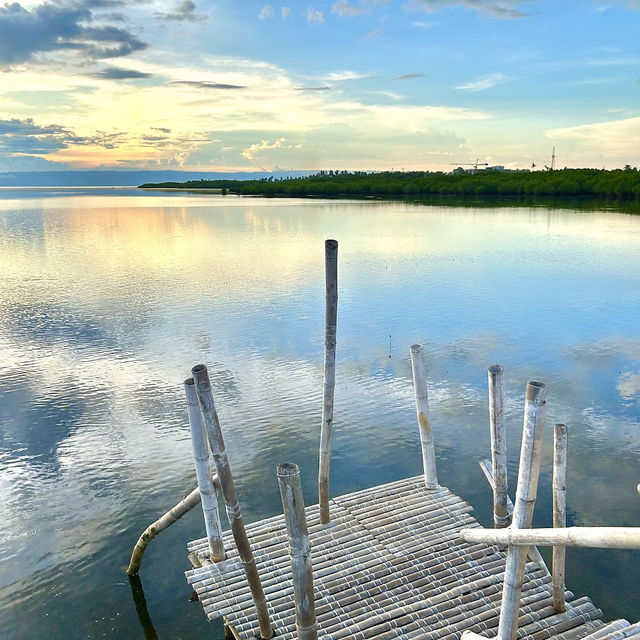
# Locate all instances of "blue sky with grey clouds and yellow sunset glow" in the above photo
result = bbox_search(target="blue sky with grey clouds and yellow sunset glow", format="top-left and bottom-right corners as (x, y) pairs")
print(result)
(0, 0), (640, 172)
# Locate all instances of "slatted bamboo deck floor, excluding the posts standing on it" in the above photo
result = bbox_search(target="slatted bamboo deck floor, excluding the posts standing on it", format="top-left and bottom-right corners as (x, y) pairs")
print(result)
(186, 476), (640, 640)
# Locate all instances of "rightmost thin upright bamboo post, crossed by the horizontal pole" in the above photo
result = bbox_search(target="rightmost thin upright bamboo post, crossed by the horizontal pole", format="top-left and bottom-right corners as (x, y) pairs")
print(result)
(551, 424), (567, 613)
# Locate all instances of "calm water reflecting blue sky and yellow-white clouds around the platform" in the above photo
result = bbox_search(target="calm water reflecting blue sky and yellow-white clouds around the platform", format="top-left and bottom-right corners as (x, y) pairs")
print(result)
(0, 189), (640, 640)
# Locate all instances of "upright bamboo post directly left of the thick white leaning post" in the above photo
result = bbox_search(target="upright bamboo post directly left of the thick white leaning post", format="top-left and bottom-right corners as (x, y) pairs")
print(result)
(487, 364), (511, 529)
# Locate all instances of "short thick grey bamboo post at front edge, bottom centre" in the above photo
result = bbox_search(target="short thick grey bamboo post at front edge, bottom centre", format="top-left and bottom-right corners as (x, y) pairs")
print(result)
(277, 462), (318, 640)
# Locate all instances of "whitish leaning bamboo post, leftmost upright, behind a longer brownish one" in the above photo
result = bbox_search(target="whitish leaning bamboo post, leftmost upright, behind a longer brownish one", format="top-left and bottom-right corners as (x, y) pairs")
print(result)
(184, 378), (225, 562)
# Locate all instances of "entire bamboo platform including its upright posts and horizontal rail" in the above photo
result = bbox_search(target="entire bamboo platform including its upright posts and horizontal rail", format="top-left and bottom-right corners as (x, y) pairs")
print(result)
(127, 240), (640, 640)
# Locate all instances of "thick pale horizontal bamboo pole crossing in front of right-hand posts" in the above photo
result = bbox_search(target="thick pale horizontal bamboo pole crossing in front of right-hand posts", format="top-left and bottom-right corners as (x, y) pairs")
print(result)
(460, 527), (640, 549)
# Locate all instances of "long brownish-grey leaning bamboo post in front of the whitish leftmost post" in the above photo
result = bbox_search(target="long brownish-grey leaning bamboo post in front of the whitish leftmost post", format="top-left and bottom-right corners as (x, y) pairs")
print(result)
(191, 364), (273, 640)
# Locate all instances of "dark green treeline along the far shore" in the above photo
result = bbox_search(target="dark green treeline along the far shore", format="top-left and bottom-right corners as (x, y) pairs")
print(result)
(141, 165), (640, 200)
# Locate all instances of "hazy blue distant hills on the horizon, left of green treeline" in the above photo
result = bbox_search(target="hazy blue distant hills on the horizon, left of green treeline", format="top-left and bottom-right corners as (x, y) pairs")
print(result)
(0, 170), (313, 187)
